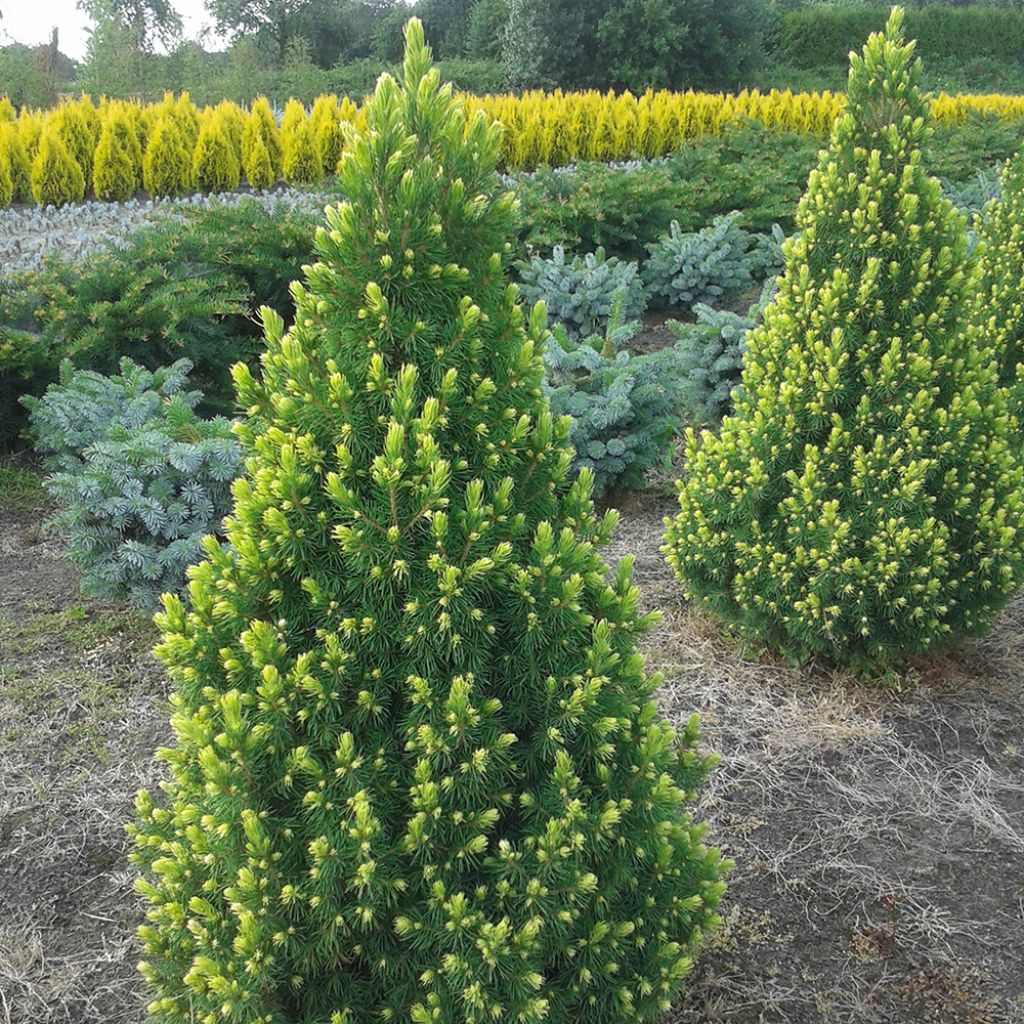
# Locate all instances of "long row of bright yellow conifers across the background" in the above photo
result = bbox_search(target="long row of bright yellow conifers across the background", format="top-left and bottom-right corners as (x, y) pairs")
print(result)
(0, 89), (1024, 204)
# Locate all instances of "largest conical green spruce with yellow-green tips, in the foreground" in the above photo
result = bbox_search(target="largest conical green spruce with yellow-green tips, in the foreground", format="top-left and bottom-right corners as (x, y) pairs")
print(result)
(130, 20), (724, 1024)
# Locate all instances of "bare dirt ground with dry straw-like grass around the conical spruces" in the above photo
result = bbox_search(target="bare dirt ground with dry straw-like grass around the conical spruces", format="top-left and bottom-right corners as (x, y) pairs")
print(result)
(0, 486), (1024, 1024)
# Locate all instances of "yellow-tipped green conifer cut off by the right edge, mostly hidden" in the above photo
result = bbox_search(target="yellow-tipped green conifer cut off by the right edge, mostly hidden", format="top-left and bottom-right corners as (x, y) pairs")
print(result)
(977, 151), (1024, 407)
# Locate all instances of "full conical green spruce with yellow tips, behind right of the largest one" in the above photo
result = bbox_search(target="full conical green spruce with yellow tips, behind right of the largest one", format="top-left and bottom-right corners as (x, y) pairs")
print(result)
(666, 8), (1024, 667)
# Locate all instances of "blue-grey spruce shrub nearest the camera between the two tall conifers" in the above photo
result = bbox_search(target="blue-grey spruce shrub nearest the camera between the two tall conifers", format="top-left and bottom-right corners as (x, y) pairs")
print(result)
(544, 294), (685, 495)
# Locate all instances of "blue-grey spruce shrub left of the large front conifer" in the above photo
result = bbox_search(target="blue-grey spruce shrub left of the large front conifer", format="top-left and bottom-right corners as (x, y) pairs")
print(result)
(25, 358), (240, 607)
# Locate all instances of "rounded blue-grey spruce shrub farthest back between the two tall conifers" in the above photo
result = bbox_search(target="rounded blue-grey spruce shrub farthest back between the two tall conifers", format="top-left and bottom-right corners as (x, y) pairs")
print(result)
(643, 213), (768, 309)
